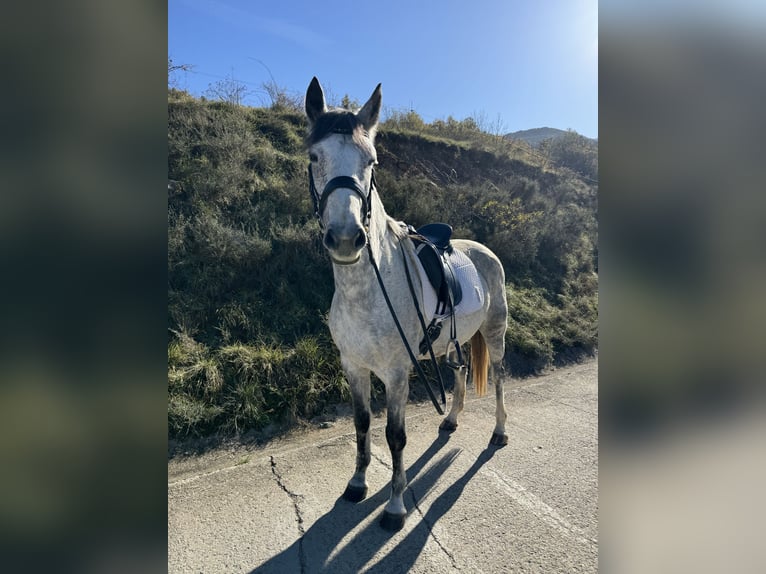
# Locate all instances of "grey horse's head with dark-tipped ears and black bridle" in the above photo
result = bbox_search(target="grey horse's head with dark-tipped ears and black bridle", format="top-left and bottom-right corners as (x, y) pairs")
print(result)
(306, 78), (381, 265)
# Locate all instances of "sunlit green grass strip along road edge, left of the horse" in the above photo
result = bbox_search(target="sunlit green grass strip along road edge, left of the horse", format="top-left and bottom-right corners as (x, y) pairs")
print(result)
(168, 333), (350, 437)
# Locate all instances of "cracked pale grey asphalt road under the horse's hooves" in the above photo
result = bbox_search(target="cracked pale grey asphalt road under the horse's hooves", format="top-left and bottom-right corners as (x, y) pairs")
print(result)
(168, 360), (598, 574)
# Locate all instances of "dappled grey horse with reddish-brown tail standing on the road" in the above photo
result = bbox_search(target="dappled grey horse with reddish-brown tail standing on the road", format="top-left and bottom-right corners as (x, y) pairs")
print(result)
(305, 77), (508, 531)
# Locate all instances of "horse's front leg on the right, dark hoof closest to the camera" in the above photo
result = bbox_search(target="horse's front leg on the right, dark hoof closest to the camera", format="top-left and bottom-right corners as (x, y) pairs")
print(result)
(380, 371), (409, 530)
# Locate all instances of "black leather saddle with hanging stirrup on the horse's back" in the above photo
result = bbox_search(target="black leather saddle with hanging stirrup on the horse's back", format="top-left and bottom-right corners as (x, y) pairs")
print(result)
(410, 223), (464, 368)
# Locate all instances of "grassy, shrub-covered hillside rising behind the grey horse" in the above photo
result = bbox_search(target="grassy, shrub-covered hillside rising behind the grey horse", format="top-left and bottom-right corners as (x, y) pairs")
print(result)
(168, 90), (598, 437)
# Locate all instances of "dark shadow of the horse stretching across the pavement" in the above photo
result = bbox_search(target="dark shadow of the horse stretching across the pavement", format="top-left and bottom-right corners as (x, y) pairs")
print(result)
(250, 432), (497, 574)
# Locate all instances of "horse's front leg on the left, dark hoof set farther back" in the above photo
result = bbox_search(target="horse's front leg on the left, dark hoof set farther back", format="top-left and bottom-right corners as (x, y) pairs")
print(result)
(343, 361), (371, 502)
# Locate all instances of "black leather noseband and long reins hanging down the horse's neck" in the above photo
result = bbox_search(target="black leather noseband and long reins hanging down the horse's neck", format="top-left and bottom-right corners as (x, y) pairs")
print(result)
(309, 164), (447, 415)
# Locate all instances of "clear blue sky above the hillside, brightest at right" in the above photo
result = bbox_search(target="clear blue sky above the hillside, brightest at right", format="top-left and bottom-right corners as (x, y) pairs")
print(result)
(168, 0), (598, 138)
